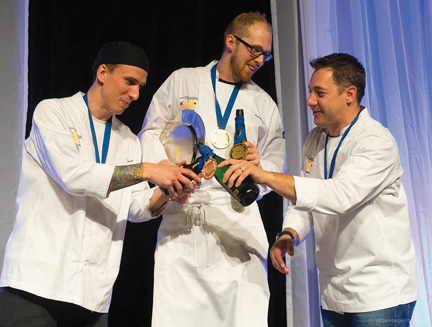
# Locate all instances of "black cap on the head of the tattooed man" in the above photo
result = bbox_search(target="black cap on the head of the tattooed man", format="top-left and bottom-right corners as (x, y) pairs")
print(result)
(93, 41), (149, 73)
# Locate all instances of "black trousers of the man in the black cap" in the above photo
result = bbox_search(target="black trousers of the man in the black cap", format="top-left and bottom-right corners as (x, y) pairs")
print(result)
(0, 287), (108, 327)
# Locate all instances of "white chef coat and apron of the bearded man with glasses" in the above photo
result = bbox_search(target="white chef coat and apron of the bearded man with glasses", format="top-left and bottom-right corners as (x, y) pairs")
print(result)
(139, 61), (285, 327)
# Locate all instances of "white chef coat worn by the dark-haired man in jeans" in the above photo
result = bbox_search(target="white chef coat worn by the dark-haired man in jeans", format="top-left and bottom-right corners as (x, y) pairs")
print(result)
(283, 107), (418, 312)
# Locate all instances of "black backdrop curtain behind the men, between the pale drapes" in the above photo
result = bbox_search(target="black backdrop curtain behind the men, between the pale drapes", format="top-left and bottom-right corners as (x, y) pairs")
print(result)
(26, 0), (286, 327)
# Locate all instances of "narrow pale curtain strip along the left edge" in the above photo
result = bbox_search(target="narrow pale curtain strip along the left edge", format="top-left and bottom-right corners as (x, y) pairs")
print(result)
(0, 0), (28, 270)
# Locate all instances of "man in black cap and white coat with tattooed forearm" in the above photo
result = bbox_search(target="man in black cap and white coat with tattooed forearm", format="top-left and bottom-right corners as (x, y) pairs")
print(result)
(0, 42), (200, 327)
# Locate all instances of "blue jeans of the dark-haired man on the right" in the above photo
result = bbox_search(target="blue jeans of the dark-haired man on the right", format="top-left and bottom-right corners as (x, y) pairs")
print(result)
(321, 301), (416, 327)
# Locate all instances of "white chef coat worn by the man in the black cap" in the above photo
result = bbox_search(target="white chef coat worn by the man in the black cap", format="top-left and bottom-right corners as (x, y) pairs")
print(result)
(0, 93), (160, 312)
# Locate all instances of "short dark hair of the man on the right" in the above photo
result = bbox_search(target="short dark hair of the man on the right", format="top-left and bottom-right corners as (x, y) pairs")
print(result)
(309, 53), (366, 103)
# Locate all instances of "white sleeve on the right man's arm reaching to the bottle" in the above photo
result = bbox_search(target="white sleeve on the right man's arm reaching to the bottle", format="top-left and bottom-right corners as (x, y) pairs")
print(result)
(294, 130), (402, 215)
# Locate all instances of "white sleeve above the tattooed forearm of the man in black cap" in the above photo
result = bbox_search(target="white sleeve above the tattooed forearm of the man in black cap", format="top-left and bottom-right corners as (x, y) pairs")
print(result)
(25, 100), (114, 199)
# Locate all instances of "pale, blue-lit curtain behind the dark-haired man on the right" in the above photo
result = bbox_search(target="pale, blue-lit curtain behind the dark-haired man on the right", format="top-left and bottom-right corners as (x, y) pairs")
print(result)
(271, 0), (432, 327)
